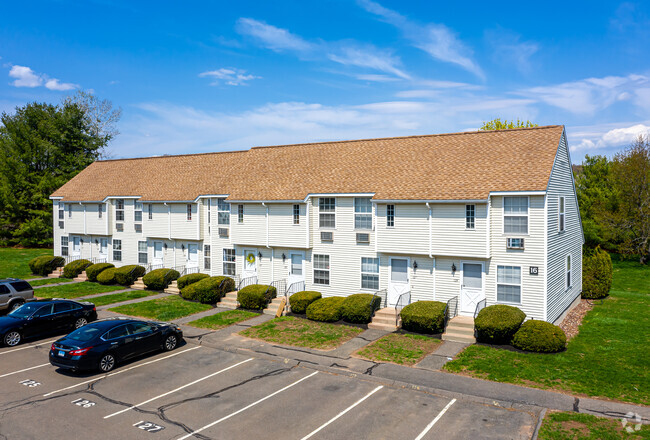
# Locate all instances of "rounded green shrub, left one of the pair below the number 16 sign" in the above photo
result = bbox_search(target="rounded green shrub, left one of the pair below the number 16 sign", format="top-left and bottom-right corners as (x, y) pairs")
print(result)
(474, 304), (526, 344)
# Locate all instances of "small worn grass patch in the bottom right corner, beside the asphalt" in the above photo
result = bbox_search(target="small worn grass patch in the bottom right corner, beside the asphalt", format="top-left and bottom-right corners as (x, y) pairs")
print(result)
(538, 412), (650, 440)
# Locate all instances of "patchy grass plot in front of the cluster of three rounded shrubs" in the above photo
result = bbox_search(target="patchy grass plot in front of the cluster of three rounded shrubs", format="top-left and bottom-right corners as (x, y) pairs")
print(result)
(239, 316), (363, 350)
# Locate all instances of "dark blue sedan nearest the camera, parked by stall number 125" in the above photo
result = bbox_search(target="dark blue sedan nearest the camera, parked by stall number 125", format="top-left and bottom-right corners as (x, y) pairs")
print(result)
(50, 318), (183, 373)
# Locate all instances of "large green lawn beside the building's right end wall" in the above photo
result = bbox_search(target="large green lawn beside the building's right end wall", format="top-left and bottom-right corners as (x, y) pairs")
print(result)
(445, 257), (650, 405)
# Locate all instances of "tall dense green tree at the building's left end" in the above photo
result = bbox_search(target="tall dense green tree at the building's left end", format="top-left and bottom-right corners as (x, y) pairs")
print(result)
(0, 95), (119, 246)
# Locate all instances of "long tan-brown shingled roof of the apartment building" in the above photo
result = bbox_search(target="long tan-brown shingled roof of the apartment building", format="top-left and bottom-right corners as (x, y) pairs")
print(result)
(52, 125), (564, 201)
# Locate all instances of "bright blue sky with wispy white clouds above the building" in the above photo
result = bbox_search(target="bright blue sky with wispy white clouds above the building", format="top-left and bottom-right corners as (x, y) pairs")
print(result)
(0, 0), (650, 163)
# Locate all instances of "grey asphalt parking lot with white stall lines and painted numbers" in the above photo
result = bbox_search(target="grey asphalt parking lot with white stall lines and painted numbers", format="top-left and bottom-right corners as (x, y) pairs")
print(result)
(0, 338), (537, 440)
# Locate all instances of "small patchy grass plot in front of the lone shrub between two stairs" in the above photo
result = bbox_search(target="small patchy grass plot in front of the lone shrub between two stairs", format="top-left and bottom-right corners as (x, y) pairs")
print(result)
(356, 333), (440, 366)
